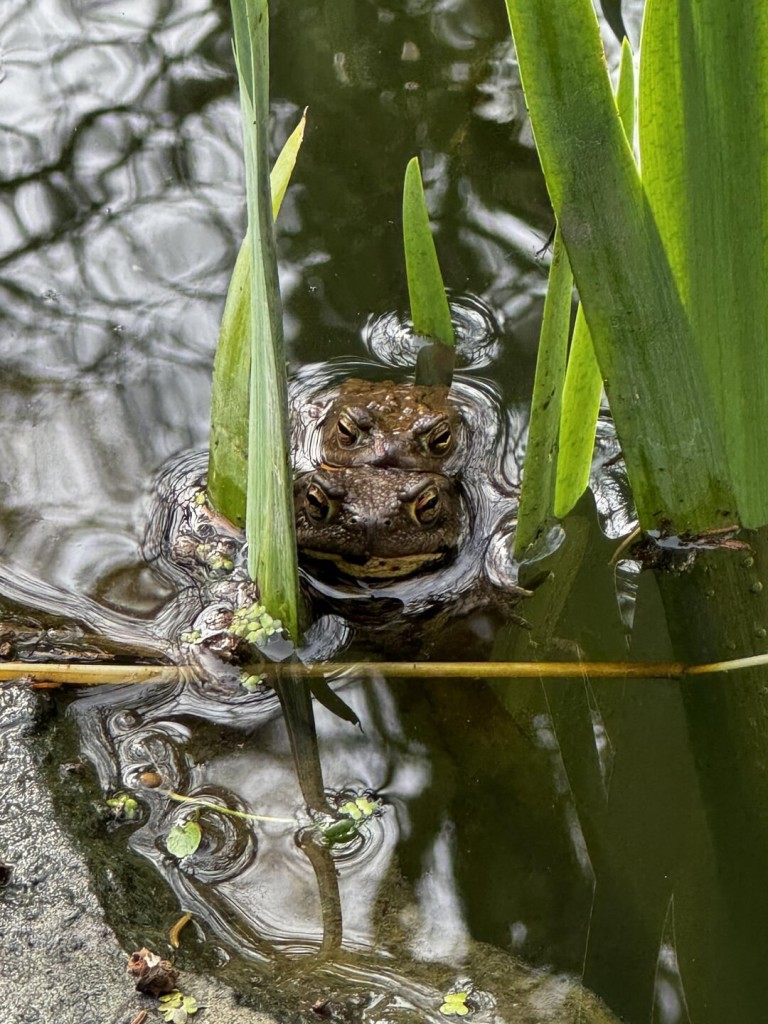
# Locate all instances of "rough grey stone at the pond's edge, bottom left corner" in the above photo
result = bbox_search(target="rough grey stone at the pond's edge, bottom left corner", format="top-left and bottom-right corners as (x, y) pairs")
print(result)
(0, 686), (282, 1024)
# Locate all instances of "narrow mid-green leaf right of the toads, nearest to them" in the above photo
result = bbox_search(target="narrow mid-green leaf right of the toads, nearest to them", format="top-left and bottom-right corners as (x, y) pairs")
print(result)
(515, 229), (573, 558)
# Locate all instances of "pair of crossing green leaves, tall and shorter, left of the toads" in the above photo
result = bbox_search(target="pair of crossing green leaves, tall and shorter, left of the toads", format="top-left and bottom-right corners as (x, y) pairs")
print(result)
(209, 0), (301, 640)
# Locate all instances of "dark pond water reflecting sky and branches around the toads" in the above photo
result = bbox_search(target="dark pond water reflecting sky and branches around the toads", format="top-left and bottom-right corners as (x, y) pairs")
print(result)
(0, 0), (758, 1024)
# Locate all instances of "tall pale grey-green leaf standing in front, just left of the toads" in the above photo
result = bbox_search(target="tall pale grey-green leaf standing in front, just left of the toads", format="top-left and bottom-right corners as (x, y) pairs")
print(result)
(232, 0), (298, 640)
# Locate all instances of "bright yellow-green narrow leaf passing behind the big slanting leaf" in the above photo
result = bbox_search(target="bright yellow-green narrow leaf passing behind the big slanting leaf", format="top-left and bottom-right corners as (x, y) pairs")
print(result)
(555, 39), (635, 519)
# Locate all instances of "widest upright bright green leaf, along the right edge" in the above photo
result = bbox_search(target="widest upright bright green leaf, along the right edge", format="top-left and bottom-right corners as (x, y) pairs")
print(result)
(639, 0), (768, 526)
